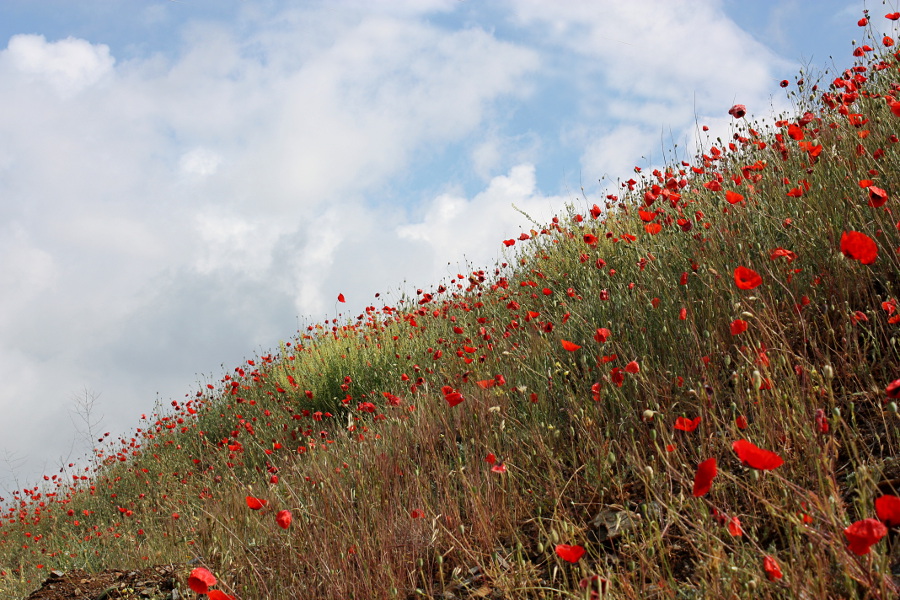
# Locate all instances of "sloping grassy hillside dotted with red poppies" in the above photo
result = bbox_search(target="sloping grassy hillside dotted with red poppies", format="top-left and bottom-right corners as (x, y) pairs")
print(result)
(0, 14), (900, 599)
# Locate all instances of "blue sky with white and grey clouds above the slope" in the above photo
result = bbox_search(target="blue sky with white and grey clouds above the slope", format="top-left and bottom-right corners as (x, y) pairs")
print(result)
(0, 0), (872, 491)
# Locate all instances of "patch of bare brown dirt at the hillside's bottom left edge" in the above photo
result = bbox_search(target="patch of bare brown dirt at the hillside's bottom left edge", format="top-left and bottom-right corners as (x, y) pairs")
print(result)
(26, 565), (187, 600)
